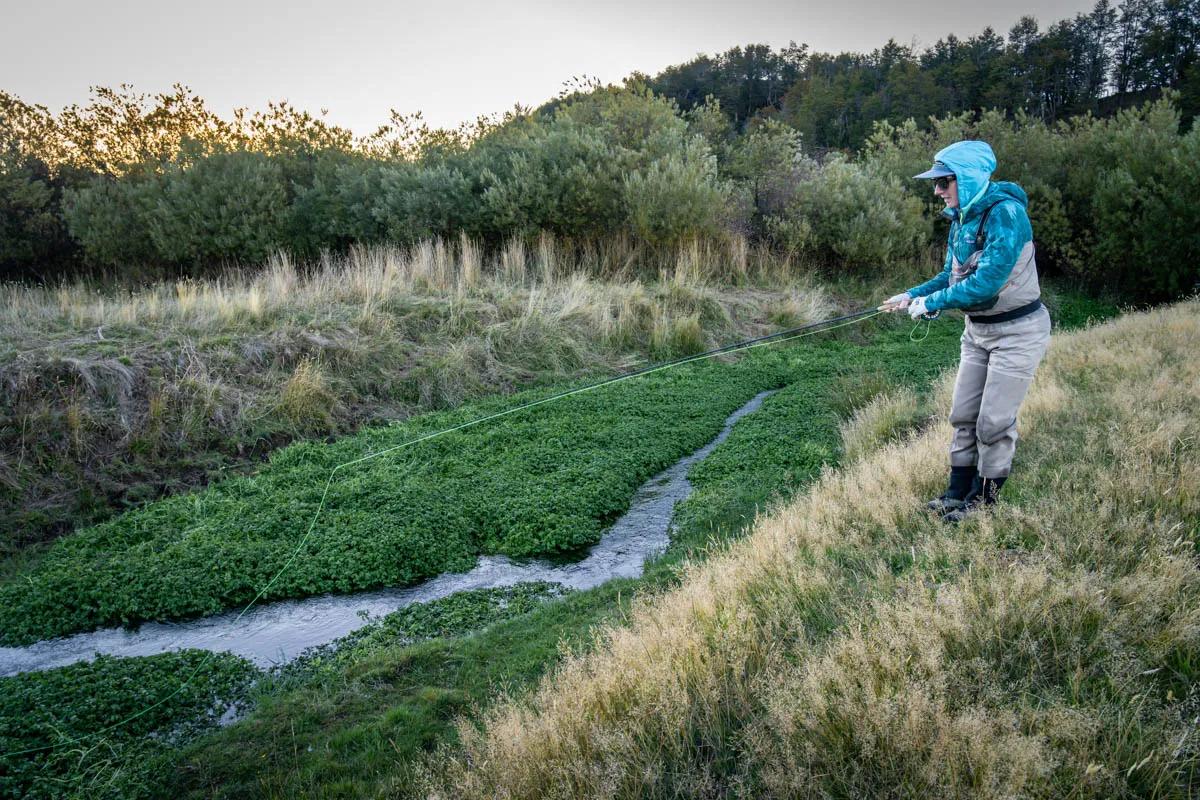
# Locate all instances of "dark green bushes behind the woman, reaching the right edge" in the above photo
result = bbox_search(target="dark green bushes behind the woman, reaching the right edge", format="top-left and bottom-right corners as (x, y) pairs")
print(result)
(864, 94), (1200, 301)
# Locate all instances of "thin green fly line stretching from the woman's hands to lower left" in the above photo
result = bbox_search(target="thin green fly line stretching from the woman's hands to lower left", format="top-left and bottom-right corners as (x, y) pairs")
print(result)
(0, 303), (888, 758)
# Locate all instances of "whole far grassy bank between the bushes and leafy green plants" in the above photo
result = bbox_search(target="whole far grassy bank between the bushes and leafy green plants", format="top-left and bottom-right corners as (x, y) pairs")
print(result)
(0, 236), (834, 555)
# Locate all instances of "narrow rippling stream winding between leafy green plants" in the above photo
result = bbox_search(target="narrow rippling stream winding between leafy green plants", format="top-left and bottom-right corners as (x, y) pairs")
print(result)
(0, 391), (774, 675)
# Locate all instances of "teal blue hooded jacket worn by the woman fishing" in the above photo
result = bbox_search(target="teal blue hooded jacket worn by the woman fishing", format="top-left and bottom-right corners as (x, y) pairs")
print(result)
(908, 142), (1033, 311)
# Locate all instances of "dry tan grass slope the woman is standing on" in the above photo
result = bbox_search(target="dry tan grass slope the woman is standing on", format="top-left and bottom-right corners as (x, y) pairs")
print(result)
(425, 301), (1200, 798)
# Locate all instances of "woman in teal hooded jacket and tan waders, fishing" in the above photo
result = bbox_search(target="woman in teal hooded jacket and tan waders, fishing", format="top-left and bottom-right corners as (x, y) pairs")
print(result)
(882, 142), (1050, 522)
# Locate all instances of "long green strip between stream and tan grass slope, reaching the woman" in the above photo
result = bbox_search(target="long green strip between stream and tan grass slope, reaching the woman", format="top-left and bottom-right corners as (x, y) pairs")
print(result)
(162, 297), (1112, 798)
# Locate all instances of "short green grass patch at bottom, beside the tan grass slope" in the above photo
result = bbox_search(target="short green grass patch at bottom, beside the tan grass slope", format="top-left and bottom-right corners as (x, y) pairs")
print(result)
(172, 579), (638, 798)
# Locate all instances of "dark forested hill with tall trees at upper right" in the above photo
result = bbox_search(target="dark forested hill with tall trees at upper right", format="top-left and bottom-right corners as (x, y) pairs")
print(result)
(641, 0), (1200, 148)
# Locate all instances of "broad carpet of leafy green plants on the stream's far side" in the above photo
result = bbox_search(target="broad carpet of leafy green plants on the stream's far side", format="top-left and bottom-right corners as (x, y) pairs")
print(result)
(0, 353), (806, 644)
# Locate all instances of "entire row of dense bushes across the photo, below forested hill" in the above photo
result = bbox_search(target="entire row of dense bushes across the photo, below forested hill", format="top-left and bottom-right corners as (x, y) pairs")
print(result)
(7, 82), (1200, 301)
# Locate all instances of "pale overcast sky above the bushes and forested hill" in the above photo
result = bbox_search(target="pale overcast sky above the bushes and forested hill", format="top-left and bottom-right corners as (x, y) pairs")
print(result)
(0, 0), (1094, 134)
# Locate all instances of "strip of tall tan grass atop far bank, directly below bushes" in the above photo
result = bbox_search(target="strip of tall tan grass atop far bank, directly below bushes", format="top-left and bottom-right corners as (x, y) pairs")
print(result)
(0, 234), (830, 335)
